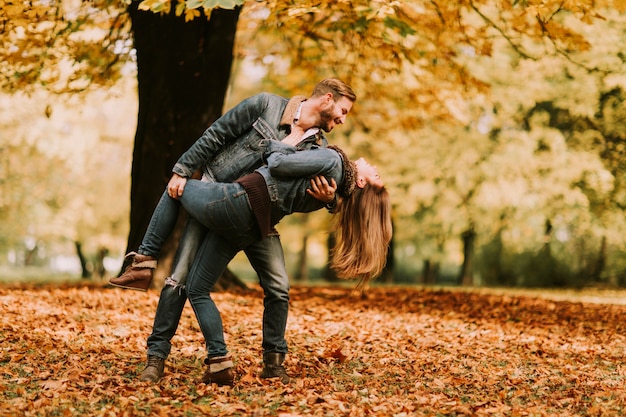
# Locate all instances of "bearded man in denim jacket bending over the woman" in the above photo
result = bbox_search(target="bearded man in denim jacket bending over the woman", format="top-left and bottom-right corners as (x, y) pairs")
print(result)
(109, 78), (356, 385)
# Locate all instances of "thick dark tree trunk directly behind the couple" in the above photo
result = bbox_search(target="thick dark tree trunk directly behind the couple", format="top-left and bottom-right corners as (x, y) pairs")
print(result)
(127, 1), (240, 282)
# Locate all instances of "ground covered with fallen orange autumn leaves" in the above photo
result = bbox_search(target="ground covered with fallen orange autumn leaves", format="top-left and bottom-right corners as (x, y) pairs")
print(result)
(0, 286), (626, 416)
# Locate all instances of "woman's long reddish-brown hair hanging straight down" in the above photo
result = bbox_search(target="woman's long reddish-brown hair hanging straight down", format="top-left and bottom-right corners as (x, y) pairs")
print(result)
(331, 184), (393, 284)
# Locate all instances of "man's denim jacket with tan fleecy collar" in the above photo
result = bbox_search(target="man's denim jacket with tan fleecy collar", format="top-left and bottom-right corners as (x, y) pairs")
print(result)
(172, 93), (328, 182)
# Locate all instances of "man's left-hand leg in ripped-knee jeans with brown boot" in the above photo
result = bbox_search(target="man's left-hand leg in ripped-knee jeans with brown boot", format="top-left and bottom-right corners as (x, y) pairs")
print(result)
(139, 219), (207, 382)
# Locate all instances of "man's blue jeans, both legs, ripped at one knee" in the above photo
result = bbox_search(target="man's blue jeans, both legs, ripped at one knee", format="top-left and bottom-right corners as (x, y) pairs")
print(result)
(148, 214), (289, 359)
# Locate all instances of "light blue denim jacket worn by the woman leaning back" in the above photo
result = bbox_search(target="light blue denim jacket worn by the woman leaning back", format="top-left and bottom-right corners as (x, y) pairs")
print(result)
(257, 140), (344, 225)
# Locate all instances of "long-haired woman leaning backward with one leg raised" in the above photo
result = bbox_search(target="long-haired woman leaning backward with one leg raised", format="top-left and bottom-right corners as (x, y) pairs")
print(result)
(111, 140), (392, 385)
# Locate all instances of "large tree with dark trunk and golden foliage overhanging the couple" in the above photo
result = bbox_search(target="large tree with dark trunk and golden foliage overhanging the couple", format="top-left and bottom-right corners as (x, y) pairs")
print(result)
(0, 0), (619, 286)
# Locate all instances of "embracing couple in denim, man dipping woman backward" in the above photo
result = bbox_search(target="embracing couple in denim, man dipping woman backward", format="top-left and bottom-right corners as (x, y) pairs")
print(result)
(110, 78), (391, 385)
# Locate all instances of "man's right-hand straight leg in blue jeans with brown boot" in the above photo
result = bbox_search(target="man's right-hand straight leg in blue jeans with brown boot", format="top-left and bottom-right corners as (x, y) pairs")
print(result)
(244, 233), (289, 383)
